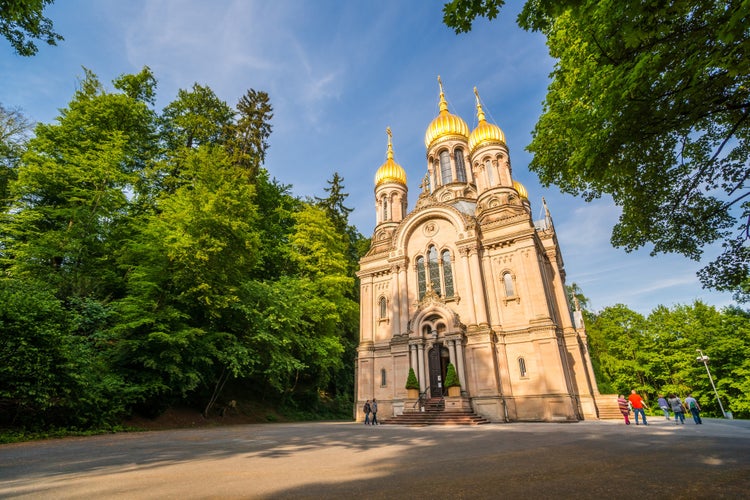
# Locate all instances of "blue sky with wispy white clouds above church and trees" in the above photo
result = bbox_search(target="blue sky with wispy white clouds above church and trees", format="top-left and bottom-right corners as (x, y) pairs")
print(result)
(0, 0), (734, 315)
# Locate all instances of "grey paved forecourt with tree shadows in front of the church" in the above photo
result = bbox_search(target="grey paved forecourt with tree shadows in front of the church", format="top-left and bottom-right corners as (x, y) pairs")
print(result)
(0, 417), (750, 499)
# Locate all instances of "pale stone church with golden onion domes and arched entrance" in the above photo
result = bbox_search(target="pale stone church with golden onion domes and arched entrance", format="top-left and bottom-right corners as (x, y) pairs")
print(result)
(355, 77), (598, 422)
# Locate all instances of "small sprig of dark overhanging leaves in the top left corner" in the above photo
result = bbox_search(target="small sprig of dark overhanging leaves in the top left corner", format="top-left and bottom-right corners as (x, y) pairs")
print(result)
(0, 0), (63, 57)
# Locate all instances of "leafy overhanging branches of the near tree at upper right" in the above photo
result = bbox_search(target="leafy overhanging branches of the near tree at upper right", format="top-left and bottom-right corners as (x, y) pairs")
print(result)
(444, 0), (750, 300)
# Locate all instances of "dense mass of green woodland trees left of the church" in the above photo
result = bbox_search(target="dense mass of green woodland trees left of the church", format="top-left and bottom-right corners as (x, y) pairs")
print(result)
(0, 68), (361, 431)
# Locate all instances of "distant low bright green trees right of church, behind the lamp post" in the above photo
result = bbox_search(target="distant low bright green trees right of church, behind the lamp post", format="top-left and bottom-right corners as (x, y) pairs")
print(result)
(586, 302), (750, 418)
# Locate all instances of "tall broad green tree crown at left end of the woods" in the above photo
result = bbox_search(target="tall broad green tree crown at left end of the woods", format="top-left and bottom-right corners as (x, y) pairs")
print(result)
(3, 70), (159, 298)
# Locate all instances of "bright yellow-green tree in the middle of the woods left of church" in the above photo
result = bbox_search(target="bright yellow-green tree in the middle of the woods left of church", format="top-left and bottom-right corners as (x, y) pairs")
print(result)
(111, 145), (259, 413)
